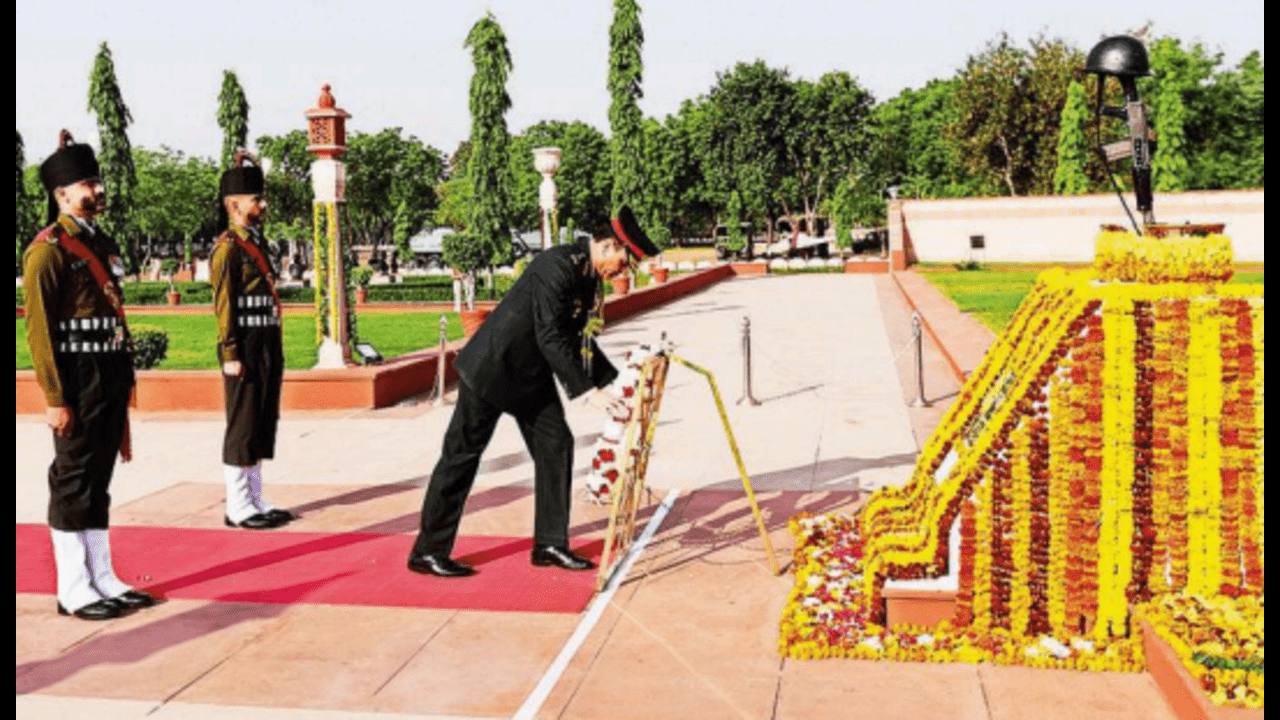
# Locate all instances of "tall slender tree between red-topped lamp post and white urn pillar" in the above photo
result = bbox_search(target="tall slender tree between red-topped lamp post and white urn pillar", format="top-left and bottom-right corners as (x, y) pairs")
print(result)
(465, 13), (512, 284)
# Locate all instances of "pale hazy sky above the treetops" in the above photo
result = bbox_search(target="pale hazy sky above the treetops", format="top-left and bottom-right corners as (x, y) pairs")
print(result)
(15, 0), (1263, 163)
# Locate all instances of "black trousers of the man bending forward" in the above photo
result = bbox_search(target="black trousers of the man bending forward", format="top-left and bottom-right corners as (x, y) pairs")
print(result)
(413, 382), (573, 555)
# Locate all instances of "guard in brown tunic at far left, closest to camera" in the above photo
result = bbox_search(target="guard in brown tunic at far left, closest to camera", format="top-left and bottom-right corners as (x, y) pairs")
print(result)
(23, 129), (156, 620)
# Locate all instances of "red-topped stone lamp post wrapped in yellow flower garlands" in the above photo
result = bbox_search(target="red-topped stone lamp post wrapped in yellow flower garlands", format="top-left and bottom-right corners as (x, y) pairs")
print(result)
(303, 85), (352, 368)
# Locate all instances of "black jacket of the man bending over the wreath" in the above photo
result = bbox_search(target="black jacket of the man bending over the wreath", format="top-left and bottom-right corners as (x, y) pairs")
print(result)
(453, 238), (618, 414)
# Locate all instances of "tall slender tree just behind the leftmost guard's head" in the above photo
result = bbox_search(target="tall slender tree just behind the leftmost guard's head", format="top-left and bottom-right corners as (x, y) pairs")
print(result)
(88, 42), (138, 273)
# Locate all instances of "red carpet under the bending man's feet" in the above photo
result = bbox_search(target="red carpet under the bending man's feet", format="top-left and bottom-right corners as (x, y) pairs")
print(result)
(17, 524), (603, 612)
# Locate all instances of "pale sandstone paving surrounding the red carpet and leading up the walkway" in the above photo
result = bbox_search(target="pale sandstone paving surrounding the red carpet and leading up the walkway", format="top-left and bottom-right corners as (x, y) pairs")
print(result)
(15, 270), (1169, 720)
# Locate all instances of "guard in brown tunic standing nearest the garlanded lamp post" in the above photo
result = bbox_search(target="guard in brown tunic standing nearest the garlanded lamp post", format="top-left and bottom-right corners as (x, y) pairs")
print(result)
(210, 151), (294, 530)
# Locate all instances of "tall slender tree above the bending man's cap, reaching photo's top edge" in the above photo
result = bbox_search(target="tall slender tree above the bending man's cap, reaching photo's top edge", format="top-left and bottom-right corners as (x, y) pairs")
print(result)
(608, 0), (649, 219)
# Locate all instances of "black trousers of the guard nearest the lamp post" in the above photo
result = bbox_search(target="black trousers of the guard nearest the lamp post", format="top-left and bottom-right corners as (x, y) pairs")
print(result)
(223, 327), (284, 468)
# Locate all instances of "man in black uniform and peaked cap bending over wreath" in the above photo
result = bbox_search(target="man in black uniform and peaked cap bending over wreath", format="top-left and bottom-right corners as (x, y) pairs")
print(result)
(408, 208), (658, 578)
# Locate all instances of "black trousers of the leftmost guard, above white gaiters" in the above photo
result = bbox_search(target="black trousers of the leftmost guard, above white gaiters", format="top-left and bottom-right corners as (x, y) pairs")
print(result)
(49, 352), (133, 532)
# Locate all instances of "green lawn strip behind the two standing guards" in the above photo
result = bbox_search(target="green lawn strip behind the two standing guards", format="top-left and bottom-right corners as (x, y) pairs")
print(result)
(14, 313), (462, 370)
